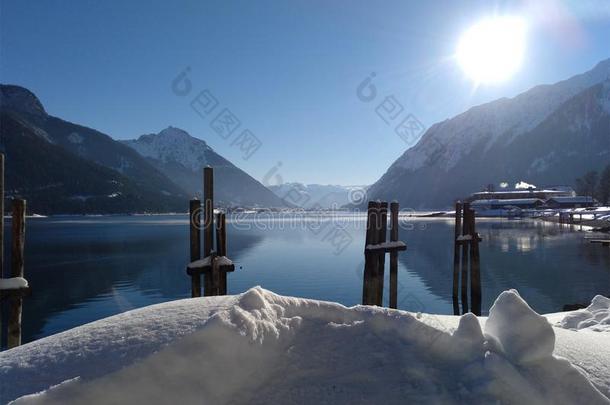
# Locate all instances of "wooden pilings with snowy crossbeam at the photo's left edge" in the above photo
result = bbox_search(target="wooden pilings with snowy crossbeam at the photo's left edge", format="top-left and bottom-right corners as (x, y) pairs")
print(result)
(0, 154), (30, 349)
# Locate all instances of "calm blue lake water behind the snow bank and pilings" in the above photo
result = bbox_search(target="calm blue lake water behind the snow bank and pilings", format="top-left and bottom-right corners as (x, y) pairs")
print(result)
(1, 215), (610, 342)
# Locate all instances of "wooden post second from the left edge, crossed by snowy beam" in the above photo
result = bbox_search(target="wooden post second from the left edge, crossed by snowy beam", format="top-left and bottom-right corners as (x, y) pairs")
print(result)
(7, 199), (25, 349)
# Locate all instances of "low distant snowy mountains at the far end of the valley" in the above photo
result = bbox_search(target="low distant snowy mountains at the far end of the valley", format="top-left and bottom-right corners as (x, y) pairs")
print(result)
(269, 183), (367, 209)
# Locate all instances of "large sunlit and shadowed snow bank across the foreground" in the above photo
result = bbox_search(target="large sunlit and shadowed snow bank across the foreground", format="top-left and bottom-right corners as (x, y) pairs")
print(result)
(0, 287), (610, 404)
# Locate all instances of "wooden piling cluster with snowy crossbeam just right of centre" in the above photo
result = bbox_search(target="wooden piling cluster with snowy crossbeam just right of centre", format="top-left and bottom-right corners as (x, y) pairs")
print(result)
(362, 201), (407, 308)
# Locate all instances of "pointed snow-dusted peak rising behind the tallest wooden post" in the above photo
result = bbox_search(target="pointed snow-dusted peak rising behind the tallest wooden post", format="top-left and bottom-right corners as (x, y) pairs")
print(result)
(122, 126), (286, 207)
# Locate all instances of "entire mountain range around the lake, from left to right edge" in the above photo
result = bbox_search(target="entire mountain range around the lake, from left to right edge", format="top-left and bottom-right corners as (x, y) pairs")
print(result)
(5, 59), (610, 214)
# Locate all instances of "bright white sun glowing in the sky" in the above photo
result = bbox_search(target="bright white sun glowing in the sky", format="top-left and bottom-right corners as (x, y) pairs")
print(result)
(456, 17), (526, 83)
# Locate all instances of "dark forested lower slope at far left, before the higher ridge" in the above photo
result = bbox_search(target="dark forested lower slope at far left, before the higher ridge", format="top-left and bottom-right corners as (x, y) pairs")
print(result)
(0, 110), (183, 214)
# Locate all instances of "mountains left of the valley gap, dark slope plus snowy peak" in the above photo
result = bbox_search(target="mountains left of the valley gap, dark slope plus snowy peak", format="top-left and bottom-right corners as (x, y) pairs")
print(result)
(0, 85), (285, 214)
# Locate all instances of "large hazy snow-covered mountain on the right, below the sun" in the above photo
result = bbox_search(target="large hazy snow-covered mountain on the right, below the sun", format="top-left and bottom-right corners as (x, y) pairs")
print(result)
(369, 59), (610, 208)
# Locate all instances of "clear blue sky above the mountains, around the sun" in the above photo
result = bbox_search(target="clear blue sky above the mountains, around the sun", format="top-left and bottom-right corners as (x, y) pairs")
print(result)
(0, 0), (610, 185)
